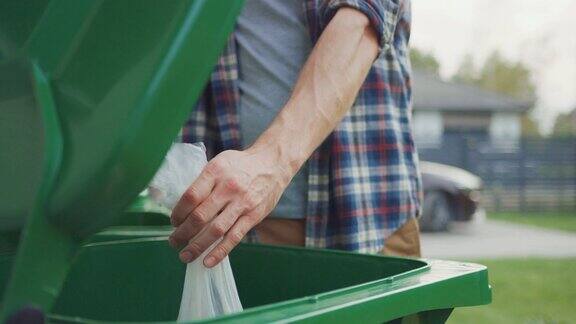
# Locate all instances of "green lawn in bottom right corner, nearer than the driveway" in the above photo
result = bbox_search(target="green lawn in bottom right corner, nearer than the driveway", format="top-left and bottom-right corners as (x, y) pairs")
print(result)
(448, 258), (576, 324)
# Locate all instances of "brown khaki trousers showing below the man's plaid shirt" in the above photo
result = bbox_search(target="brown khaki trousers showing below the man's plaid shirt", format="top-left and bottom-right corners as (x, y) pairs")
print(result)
(256, 218), (420, 257)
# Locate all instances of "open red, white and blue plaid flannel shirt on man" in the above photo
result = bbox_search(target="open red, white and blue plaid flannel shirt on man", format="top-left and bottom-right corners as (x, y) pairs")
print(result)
(181, 0), (421, 253)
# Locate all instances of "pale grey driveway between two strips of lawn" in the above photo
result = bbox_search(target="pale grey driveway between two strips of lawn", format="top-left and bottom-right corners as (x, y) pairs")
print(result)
(422, 220), (576, 260)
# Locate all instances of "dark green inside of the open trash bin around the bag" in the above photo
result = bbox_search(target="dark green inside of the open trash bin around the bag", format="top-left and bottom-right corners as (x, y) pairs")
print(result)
(0, 239), (426, 321)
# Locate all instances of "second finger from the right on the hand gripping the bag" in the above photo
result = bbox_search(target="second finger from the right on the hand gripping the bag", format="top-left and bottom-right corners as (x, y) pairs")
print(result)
(180, 203), (242, 262)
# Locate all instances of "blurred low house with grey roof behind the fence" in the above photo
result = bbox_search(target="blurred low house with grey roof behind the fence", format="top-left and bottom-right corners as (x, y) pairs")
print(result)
(412, 70), (533, 148)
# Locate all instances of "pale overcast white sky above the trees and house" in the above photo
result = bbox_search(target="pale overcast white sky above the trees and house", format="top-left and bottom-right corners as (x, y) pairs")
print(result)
(411, 0), (576, 133)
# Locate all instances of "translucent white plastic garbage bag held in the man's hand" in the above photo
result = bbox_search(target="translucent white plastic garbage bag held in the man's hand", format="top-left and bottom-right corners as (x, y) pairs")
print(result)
(149, 143), (242, 321)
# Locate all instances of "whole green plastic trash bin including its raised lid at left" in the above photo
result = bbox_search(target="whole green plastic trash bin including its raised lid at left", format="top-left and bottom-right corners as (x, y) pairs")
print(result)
(0, 0), (490, 323)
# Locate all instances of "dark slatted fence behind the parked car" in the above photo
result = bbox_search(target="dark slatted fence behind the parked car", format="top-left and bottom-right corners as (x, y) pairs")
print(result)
(419, 136), (576, 214)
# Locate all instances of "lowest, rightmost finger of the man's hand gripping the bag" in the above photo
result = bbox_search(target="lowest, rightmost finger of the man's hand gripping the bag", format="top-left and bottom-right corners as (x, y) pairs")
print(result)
(203, 214), (256, 268)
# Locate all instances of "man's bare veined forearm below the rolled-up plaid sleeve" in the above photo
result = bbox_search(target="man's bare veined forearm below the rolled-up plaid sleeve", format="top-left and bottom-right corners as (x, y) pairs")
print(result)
(249, 8), (378, 174)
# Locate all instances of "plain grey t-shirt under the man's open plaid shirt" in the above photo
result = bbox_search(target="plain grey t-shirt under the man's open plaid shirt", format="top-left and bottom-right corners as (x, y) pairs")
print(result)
(236, 0), (312, 218)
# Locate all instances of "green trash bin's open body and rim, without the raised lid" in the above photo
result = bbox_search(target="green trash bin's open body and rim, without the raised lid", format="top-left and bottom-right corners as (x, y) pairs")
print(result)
(0, 237), (490, 323)
